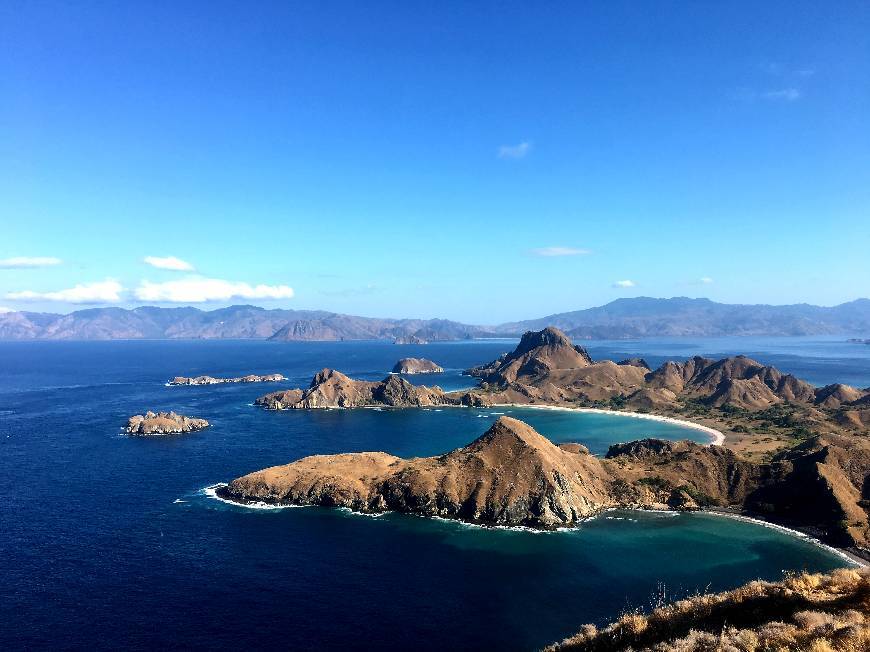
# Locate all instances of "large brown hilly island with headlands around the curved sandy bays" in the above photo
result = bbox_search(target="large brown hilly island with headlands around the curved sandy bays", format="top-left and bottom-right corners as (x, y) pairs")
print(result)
(232, 327), (870, 555)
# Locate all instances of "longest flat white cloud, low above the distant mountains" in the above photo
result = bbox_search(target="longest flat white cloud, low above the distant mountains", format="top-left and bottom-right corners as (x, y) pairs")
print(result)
(135, 276), (293, 303)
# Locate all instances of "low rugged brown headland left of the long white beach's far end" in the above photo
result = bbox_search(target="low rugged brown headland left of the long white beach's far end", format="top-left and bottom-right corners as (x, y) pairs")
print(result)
(254, 369), (470, 410)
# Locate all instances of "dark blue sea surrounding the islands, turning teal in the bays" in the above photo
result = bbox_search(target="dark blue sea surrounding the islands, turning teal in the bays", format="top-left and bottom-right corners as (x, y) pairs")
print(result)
(0, 341), (870, 649)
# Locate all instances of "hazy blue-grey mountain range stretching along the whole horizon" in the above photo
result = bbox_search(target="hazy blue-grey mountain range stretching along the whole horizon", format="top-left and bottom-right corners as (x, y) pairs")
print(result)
(0, 297), (870, 342)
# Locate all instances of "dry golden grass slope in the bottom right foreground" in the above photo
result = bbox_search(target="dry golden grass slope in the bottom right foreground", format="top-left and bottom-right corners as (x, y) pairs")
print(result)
(548, 568), (870, 652)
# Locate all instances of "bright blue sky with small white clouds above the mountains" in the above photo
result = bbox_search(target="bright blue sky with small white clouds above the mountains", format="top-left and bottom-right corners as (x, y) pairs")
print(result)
(0, 0), (870, 323)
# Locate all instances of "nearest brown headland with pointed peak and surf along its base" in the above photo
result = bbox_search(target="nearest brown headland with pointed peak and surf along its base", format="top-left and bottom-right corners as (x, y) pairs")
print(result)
(221, 417), (613, 528)
